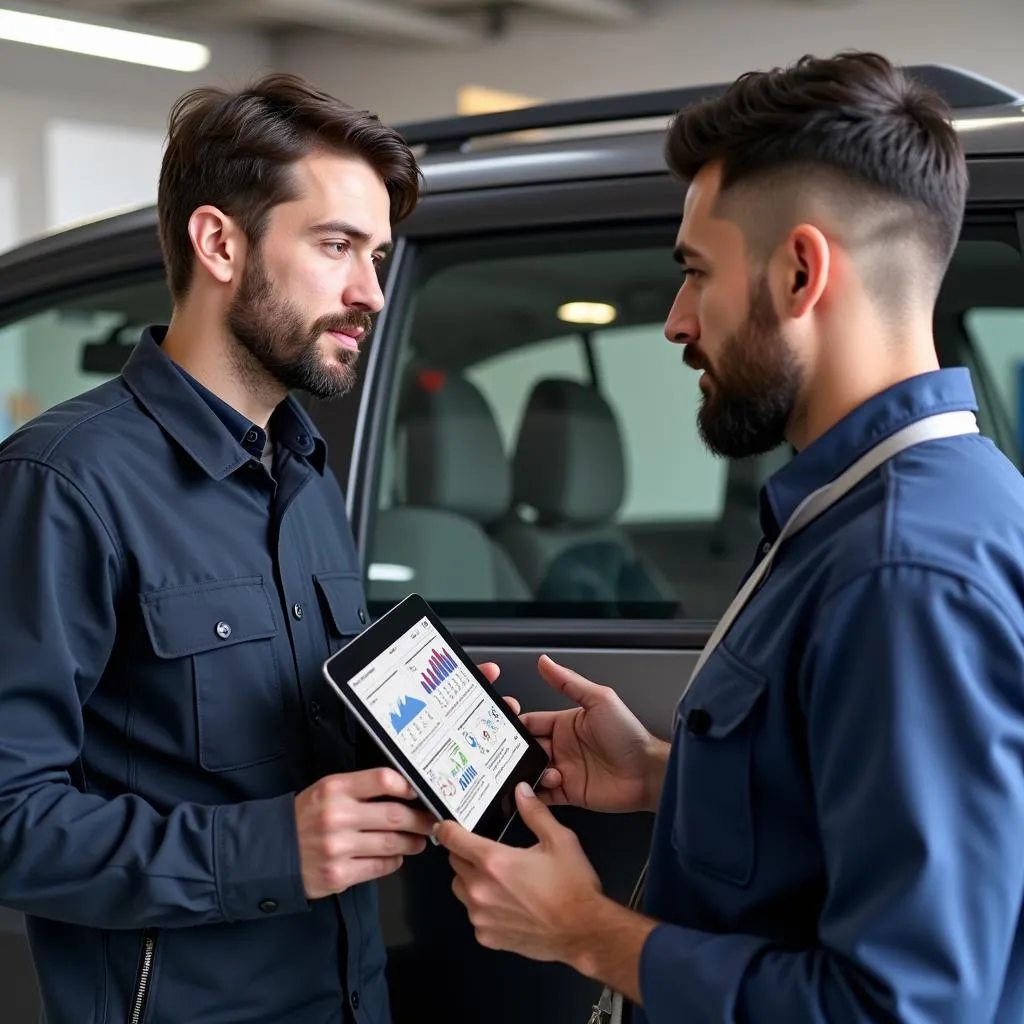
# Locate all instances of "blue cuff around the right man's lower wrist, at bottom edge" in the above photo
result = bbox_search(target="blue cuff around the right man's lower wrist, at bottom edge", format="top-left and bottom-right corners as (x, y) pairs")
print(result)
(640, 925), (767, 1024)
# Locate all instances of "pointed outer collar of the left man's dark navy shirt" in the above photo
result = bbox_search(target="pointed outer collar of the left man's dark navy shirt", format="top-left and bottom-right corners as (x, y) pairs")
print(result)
(122, 327), (327, 480)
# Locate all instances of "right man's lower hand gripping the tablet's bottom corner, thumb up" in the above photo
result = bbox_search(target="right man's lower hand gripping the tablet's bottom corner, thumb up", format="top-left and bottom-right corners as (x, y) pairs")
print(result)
(435, 783), (603, 964)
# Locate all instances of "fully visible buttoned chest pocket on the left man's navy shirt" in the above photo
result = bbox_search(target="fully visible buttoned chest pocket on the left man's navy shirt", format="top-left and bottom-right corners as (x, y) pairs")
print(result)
(141, 577), (285, 772)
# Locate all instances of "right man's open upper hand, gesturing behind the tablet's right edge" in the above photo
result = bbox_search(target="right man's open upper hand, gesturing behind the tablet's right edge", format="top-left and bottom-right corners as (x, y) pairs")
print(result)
(521, 655), (669, 812)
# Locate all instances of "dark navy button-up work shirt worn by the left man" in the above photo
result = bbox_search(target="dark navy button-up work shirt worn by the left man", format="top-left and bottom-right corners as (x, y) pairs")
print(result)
(0, 330), (389, 1024)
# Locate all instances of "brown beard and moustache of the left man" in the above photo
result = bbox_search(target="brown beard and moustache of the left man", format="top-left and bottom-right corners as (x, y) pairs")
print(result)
(226, 250), (373, 398)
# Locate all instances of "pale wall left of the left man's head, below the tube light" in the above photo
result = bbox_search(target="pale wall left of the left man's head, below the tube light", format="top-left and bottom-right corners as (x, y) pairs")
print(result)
(0, 24), (273, 249)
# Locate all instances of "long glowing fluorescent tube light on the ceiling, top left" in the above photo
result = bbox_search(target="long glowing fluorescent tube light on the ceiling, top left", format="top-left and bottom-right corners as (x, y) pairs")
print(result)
(0, 8), (210, 72)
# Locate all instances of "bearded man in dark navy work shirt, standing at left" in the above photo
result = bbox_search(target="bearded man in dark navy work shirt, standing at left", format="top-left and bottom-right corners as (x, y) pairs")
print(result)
(0, 75), (432, 1024)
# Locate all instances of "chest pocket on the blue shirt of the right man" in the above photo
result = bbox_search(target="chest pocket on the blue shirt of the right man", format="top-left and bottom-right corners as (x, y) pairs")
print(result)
(673, 646), (768, 885)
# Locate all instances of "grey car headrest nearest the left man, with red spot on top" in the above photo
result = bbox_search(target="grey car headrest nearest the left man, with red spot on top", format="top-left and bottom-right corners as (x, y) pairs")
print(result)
(397, 370), (512, 524)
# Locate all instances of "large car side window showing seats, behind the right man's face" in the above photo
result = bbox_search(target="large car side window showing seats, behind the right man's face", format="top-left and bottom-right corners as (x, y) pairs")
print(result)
(368, 224), (1024, 620)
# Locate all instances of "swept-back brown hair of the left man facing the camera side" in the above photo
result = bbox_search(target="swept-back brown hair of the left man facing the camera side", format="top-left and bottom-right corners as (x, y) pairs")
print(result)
(157, 73), (421, 301)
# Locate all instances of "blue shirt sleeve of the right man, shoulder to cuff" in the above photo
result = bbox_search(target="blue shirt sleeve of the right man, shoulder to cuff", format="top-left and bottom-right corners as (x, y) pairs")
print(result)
(640, 565), (1024, 1024)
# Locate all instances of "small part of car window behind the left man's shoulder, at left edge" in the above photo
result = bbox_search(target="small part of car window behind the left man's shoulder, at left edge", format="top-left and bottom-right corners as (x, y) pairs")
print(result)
(0, 279), (170, 439)
